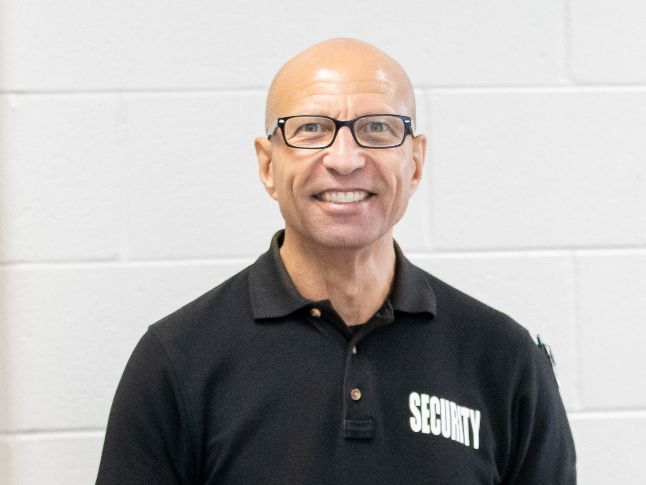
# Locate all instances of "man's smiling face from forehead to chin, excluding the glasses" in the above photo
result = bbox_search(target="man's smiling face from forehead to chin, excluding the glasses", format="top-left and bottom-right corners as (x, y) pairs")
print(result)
(255, 52), (426, 249)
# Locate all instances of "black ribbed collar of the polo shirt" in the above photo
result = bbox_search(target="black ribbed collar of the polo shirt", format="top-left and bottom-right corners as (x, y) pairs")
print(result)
(249, 230), (437, 320)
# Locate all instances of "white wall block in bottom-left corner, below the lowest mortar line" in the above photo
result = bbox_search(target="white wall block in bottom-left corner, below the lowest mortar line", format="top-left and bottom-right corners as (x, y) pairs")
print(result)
(0, 432), (103, 485)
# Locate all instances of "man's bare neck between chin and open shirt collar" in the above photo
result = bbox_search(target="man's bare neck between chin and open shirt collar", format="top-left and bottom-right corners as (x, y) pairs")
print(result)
(280, 228), (395, 325)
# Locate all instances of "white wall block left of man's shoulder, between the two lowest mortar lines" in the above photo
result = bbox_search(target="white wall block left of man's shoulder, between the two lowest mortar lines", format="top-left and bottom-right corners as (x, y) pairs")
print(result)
(0, 260), (251, 432)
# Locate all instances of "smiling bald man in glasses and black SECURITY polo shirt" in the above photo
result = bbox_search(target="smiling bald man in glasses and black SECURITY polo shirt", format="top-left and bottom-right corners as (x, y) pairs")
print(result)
(97, 39), (575, 485)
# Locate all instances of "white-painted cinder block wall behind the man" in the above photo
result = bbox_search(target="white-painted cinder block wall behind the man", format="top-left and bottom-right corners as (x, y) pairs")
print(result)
(0, 0), (646, 485)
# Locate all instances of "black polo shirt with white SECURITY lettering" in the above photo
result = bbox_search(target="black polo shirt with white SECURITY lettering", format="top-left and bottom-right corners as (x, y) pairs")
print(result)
(97, 232), (575, 485)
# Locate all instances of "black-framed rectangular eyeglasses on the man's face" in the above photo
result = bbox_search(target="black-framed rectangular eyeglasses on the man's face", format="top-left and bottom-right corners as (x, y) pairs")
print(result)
(267, 114), (414, 149)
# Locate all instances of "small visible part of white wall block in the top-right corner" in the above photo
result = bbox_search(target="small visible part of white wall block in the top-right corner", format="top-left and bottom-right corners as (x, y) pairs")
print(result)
(569, 0), (646, 84)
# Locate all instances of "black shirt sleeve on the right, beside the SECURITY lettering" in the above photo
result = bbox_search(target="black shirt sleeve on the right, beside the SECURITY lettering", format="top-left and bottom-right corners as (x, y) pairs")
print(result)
(503, 336), (576, 485)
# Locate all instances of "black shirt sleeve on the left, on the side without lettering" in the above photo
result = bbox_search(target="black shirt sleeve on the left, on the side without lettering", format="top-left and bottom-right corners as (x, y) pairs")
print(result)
(96, 329), (195, 485)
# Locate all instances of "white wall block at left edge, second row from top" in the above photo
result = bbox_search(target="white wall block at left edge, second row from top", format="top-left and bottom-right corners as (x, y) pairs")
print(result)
(0, 95), (122, 262)
